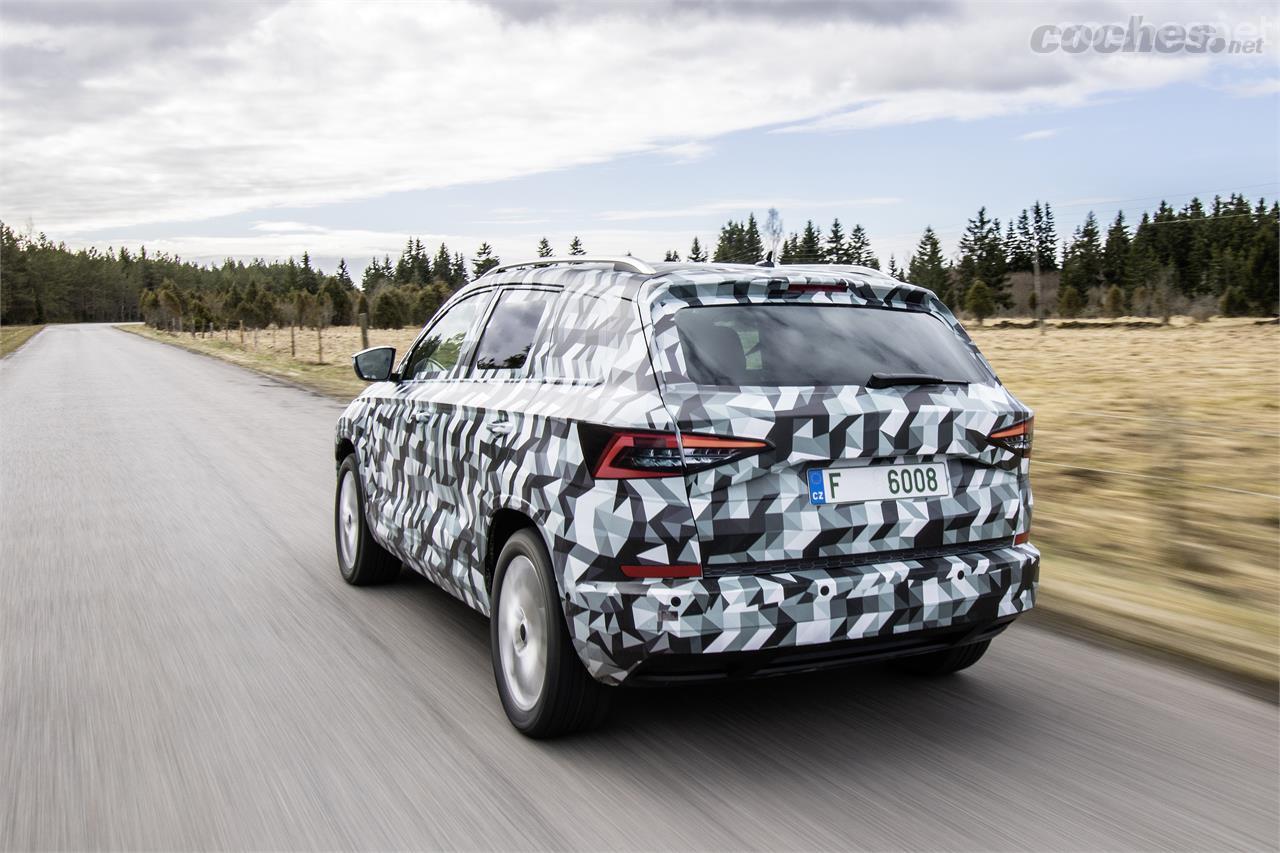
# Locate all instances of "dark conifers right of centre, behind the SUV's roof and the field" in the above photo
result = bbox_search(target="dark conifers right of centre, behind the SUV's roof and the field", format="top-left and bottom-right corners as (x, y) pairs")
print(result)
(686, 193), (1280, 320)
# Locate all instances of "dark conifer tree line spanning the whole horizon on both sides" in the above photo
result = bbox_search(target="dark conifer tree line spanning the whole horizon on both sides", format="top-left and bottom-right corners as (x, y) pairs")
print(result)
(0, 195), (1280, 330)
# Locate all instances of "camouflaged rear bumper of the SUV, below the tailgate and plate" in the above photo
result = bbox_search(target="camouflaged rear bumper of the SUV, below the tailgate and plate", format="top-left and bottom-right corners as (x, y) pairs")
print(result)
(566, 546), (1039, 684)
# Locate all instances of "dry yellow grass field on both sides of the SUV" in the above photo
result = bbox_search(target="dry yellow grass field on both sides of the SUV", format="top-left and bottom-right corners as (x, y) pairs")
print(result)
(127, 319), (1280, 684)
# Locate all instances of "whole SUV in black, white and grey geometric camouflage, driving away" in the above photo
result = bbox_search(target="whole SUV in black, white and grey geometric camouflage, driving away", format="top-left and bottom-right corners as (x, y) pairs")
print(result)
(335, 257), (1039, 736)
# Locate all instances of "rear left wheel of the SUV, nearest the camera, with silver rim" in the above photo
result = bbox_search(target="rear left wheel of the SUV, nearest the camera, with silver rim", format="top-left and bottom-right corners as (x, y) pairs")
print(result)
(489, 528), (612, 738)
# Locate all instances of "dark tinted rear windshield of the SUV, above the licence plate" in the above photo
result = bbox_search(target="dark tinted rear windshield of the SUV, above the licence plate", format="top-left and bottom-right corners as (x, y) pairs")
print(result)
(676, 305), (992, 386)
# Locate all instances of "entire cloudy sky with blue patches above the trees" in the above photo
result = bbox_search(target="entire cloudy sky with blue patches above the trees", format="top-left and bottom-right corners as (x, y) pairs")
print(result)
(0, 0), (1280, 269)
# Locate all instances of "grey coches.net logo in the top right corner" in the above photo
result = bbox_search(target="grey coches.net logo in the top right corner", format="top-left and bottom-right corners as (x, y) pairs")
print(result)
(1032, 15), (1270, 54)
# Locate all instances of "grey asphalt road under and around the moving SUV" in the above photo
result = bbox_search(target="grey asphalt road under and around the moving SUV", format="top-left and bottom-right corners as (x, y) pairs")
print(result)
(0, 325), (1280, 849)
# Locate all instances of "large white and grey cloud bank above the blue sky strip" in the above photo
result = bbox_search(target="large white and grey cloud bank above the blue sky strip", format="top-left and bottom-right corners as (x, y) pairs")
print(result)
(0, 0), (1267, 233)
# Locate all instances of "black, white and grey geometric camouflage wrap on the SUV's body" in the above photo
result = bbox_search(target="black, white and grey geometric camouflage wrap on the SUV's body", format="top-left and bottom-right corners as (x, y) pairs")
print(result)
(337, 258), (1039, 683)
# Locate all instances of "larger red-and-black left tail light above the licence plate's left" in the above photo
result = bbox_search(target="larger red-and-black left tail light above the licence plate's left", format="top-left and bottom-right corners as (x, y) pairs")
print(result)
(582, 428), (769, 480)
